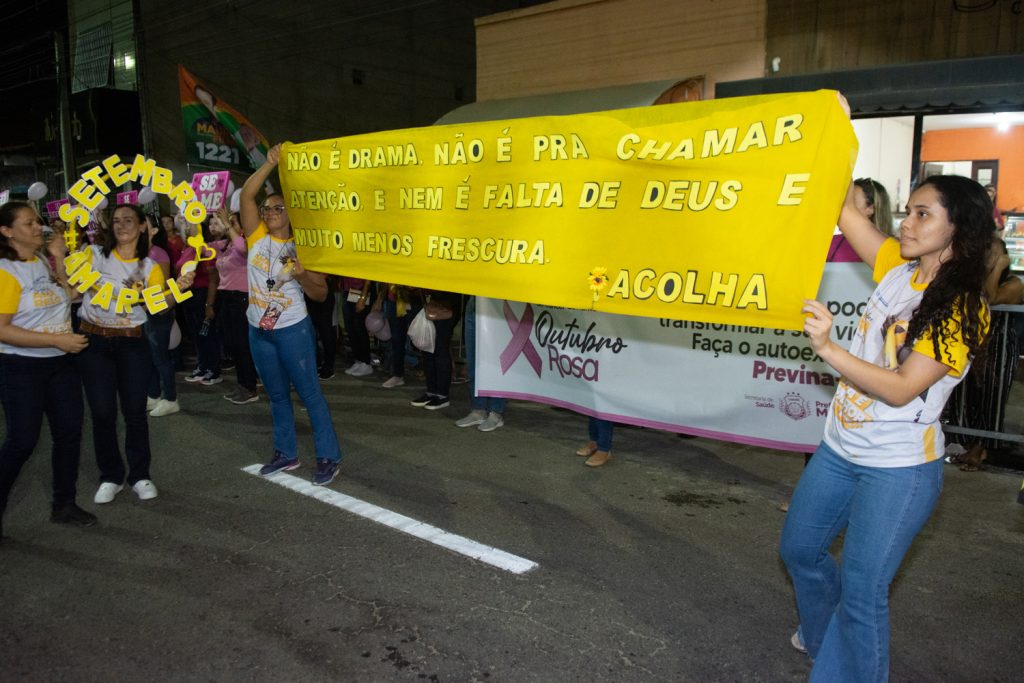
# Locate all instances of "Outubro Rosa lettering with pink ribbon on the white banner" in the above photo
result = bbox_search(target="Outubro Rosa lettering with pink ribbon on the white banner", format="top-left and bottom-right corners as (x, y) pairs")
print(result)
(500, 301), (629, 382)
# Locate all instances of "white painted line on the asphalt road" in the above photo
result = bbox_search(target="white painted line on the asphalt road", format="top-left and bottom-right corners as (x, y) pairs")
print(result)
(242, 465), (540, 573)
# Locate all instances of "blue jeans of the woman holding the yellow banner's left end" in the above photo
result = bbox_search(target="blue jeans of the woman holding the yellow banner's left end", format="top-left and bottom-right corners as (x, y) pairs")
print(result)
(249, 316), (341, 462)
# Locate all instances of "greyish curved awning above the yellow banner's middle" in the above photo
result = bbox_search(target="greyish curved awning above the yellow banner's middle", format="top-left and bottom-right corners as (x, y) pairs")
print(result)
(436, 80), (679, 125)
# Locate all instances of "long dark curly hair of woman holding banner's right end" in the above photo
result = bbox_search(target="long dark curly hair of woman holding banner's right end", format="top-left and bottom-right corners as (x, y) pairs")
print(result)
(906, 175), (995, 365)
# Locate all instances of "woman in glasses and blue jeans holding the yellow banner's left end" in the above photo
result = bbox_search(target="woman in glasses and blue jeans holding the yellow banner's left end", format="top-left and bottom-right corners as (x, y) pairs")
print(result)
(239, 144), (341, 486)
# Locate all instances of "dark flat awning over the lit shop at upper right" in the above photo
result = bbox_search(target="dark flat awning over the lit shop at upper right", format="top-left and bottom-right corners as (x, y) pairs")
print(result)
(715, 54), (1024, 115)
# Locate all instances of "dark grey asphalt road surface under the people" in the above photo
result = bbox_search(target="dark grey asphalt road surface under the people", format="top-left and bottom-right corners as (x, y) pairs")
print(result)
(0, 375), (1024, 683)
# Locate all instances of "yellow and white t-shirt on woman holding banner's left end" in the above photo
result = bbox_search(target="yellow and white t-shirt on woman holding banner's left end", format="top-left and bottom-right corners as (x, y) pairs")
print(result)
(246, 223), (307, 330)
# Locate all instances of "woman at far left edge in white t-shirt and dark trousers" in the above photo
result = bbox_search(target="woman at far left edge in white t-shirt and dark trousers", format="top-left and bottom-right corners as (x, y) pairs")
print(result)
(0, 202), (96, 538)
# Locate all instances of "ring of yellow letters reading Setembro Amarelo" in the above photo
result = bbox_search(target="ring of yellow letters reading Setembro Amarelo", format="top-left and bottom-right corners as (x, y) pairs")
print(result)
(59, 155), (216, 313)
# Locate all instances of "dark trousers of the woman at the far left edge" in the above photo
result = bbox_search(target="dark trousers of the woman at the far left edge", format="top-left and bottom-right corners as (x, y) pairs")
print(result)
(0, 353), (83, 516)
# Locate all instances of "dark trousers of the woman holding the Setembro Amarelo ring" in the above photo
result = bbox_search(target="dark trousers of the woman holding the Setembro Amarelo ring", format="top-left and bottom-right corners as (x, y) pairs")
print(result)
(78, 335), (153, 484)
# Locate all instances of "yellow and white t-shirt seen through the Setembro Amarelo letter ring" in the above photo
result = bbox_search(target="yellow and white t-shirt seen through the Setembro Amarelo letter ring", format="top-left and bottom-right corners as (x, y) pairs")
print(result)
(78, 245), (165, 328)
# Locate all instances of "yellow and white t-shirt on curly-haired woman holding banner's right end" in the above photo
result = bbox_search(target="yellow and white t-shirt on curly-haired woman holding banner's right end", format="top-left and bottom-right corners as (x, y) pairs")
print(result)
(824, 239), (971, 467)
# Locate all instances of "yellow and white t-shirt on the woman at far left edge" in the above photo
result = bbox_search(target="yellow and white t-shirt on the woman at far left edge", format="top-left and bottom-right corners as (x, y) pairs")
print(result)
(0, 257), (72, 358)
